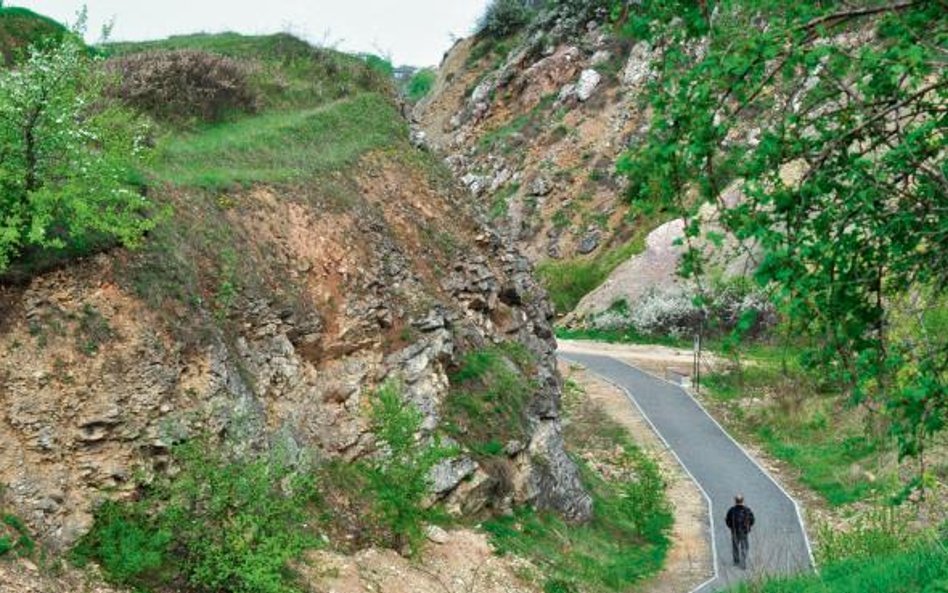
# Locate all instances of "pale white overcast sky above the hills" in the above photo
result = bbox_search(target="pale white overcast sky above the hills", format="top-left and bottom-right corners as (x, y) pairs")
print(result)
(6, 0), (488, 66)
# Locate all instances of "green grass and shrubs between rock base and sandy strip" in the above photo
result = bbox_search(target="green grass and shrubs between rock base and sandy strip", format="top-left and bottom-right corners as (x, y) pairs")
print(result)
(482, 380), (673, 593)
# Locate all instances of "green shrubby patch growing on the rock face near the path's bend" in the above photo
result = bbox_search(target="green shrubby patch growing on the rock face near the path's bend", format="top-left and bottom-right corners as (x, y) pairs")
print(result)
(444, 344), (535, 457)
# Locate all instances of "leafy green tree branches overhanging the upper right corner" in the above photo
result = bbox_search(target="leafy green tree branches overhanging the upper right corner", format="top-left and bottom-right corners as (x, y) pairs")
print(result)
(620, 0), (948, 462)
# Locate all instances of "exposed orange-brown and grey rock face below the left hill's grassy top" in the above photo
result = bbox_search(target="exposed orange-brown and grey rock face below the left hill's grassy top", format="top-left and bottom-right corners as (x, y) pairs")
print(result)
(0, 149), (591, 549)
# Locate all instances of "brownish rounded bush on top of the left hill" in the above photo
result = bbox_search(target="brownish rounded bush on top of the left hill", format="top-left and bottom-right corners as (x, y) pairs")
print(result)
(107, 49), (257, 122)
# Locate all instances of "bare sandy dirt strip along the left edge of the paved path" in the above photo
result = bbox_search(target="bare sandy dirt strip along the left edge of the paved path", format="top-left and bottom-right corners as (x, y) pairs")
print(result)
(560, 362), (713, 593)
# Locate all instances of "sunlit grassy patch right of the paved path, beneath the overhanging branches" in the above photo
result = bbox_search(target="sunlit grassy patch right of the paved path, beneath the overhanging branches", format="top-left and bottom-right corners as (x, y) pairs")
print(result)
(702, 346), (897, 506)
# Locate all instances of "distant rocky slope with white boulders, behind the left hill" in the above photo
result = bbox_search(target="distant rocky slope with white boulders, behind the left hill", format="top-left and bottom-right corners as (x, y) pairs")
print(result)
(413, 9), (656, 263)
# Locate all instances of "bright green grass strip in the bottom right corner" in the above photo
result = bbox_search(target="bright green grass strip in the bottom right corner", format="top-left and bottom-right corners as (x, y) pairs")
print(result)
(730, 543), (948, 593)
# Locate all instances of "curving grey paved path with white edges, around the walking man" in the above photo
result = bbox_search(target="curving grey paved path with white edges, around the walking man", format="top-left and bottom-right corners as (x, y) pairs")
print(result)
(559, 347), (813, 593)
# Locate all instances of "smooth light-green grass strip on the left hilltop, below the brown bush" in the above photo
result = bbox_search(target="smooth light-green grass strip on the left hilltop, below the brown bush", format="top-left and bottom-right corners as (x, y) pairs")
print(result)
(154, 93), (406, 189)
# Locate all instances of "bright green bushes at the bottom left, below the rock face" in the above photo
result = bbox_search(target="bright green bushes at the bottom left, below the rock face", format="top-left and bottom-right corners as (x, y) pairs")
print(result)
(73, 443), (316, 593)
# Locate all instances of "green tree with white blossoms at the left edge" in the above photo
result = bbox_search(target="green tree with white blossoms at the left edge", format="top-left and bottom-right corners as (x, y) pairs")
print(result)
(0, 39), (154, 272)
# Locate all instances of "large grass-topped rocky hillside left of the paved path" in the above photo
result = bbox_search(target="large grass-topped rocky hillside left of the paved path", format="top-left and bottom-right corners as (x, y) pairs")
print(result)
(0, 17), (648, 590)
